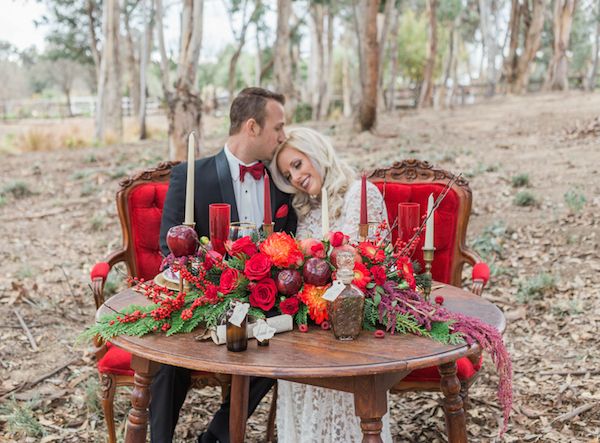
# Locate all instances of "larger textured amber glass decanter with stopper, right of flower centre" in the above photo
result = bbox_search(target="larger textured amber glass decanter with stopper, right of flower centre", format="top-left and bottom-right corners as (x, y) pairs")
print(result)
(329, 252), (365, 340)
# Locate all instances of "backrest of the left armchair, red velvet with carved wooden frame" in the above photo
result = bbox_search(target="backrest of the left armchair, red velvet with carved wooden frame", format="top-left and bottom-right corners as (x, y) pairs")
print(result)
(117, 162), (178, 279)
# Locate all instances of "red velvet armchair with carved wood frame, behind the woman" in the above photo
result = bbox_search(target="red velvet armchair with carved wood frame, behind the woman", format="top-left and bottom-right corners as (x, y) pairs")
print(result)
(369, 160), (489, 402)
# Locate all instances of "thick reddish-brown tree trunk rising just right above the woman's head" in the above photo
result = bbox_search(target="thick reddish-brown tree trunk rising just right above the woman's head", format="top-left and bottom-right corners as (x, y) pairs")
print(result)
(357, 0), (379, 131)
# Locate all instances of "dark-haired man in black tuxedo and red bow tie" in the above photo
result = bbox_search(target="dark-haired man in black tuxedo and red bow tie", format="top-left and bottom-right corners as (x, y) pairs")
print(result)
(150, 88), (297, 443)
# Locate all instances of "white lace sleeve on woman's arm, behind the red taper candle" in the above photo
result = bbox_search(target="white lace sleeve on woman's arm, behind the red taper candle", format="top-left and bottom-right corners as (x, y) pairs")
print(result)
(339, 181), (388, 240)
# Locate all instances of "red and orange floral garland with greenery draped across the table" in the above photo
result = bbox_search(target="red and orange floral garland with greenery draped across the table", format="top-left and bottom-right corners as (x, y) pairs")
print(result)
(82, 226), (512, 433)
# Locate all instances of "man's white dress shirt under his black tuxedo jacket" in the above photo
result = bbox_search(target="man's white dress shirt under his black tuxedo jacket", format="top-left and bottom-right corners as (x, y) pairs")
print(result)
(225, 145), (265, 228)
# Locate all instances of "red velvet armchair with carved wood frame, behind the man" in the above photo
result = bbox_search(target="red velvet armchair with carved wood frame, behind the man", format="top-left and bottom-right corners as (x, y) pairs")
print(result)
(91, 162), (230, 443)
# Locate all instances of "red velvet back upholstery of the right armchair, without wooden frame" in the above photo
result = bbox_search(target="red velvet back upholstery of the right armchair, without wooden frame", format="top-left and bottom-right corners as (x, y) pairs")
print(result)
(373, 181), (460, 283)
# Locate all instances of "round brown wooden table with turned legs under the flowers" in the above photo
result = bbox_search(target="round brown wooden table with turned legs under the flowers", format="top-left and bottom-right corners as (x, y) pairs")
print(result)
(96, 285), (506, 443)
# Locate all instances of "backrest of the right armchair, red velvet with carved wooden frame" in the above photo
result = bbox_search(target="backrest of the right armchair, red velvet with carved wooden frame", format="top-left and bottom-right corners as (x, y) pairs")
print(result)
(369, 160), (472, 286)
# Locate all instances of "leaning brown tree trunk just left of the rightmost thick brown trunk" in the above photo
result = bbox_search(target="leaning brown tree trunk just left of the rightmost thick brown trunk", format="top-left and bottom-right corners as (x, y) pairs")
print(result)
(511, 0), (546, 94)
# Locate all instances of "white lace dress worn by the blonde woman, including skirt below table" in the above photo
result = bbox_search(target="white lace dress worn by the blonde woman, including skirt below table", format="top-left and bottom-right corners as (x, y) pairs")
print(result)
(277, 181), (392, 443)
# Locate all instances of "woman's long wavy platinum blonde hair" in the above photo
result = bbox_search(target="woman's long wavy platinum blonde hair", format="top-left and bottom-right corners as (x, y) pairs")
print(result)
(269, 127), (356, 219)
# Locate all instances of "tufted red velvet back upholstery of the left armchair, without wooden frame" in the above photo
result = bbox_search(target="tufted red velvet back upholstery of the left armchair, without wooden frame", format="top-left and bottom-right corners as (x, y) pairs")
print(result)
(129, 182), (169, 280)
